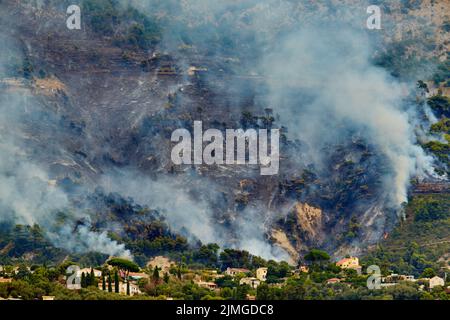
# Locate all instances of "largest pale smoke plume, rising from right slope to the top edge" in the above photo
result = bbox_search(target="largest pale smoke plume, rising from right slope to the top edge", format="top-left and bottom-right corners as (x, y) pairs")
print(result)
(127, 0), (440, 209)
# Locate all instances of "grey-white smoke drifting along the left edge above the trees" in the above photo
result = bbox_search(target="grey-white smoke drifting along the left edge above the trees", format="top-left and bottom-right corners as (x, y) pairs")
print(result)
(0, 36), (131, 257)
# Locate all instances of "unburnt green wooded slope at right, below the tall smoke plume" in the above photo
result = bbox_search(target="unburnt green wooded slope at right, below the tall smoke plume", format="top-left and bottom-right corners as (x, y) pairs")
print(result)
(365, 193), (450, 277)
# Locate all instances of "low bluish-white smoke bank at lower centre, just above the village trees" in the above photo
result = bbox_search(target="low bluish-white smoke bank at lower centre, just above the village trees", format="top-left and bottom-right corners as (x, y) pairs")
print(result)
(99, 170), (286, 259)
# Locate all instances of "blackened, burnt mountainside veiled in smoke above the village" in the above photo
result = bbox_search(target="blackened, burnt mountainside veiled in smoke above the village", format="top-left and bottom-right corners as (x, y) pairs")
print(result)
(1, 0), (448, 260)
